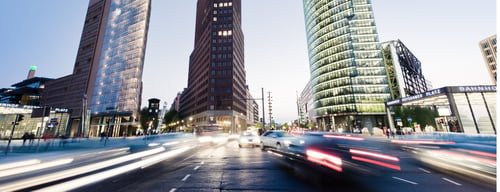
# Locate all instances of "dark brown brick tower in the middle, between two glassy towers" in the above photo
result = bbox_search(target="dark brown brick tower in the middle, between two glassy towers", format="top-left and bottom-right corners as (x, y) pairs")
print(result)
(179, 0), (247, 134)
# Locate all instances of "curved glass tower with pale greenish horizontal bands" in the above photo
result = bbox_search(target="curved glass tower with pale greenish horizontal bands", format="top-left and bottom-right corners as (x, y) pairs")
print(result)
(303, 0), (391, 131)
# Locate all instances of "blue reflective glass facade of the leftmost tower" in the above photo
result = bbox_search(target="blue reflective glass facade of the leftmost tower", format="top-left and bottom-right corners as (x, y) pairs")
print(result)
(90, 0), (150, 115)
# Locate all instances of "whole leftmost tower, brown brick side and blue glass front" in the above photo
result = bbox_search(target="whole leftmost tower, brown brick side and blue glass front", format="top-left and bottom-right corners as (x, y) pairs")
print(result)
(42, 0), (151, 136)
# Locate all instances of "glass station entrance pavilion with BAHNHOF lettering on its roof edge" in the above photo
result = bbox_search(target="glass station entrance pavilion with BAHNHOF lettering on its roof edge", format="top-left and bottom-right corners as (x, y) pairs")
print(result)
(386, 85), (497, 134)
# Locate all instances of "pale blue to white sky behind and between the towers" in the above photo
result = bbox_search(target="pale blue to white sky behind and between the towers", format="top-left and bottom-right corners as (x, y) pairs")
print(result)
(0, 0), (497, 123)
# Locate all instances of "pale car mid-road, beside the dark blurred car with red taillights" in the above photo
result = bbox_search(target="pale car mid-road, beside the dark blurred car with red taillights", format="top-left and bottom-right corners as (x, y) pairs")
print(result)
(260, 130), (301, 150)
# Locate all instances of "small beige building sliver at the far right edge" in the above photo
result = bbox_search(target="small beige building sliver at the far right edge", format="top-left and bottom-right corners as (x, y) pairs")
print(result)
(479, 35), (497, 85)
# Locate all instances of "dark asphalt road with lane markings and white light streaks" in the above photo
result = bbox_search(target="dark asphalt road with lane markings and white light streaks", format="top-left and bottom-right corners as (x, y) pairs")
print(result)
(0, 134), (496, 192)
